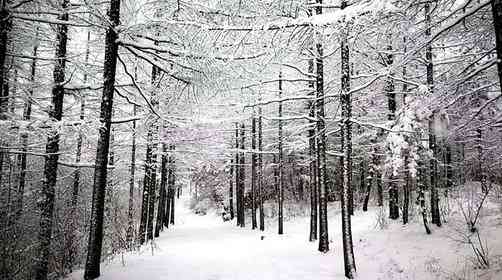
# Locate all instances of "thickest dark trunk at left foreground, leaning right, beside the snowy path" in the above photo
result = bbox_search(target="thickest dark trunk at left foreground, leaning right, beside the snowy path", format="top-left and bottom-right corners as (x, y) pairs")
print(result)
(84, 0), (120, 280)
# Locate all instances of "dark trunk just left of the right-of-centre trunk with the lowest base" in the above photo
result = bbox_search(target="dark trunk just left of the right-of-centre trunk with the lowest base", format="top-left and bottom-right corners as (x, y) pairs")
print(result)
(315, 0), (329, 253)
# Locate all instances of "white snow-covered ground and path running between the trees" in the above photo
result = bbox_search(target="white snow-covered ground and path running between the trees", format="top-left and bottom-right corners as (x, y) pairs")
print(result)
(70, 189), (502, 280)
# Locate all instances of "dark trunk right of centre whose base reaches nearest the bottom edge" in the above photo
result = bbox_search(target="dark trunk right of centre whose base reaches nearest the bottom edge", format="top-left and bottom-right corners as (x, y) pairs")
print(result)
(340, 0), (356, 279)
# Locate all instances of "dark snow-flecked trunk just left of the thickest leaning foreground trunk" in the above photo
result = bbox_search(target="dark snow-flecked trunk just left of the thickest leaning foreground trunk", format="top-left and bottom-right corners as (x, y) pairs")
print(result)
(33, 0), (69, 280)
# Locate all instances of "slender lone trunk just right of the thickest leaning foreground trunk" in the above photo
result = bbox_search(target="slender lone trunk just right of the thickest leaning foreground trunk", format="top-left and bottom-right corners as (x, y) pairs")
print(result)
(126, 105), (137, 247)
